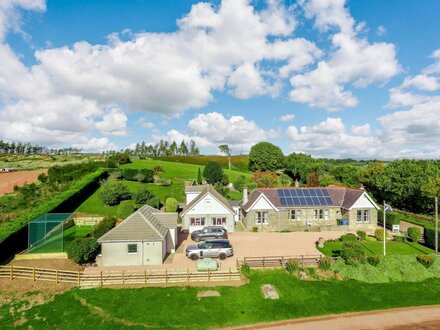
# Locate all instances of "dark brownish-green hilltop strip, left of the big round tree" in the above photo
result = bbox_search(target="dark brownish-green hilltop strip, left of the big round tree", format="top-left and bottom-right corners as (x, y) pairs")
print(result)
(155, 156), (249, 172)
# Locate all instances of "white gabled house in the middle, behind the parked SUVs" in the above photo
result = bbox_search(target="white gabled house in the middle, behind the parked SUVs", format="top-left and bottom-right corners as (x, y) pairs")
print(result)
(180, 184), (235, 233)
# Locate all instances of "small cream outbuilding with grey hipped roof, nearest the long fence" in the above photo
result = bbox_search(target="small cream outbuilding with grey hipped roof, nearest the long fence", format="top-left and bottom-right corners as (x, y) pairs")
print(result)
(98, 205), (178, 266)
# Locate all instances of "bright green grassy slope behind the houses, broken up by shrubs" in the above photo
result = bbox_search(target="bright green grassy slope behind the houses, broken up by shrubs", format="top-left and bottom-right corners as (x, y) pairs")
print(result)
(76, 160), (250, 216)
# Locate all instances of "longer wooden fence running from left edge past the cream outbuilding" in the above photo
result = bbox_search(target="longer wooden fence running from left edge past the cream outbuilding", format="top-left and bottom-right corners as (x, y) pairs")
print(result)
(0, 266), (241, 286)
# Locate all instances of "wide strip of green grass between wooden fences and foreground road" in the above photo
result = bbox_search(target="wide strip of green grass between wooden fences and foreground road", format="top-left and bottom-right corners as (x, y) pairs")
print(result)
(4, 270), (440, 330)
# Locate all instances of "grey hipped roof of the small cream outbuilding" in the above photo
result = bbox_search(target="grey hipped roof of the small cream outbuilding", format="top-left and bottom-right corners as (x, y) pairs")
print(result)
(98, 205), (177, 243)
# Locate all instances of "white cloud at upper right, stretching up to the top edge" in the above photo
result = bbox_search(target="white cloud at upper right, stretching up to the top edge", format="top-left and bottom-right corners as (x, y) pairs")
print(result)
(290, 0), (400, 111)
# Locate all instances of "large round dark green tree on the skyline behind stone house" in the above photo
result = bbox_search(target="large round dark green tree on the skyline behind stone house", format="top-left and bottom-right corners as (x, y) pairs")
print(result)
(249, 142), (285, 171)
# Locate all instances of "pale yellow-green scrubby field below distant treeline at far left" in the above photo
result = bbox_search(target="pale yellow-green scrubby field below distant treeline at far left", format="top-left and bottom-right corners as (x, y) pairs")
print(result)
(0, 154), (105, 171)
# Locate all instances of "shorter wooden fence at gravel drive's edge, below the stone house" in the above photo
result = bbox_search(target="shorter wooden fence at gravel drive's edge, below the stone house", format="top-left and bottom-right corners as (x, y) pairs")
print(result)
(237, 255), (322, 269)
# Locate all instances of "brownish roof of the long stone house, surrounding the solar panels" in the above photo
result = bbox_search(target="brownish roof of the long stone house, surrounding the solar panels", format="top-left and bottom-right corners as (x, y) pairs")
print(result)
(243, 186), (374, 210)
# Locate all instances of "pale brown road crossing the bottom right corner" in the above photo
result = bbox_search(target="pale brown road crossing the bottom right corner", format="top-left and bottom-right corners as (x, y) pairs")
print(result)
(237, 306), (440, 330)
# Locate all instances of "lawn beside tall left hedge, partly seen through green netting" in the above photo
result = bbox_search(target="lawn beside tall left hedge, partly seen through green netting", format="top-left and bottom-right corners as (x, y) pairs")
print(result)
(29, 226), (93, 253)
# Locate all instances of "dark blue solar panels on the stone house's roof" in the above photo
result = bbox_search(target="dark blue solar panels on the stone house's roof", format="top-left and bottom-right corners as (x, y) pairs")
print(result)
(278, 188), (333, 206)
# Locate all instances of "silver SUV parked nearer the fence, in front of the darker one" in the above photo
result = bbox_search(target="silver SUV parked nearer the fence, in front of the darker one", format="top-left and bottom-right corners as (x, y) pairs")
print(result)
(186, 239), (234, 260)
